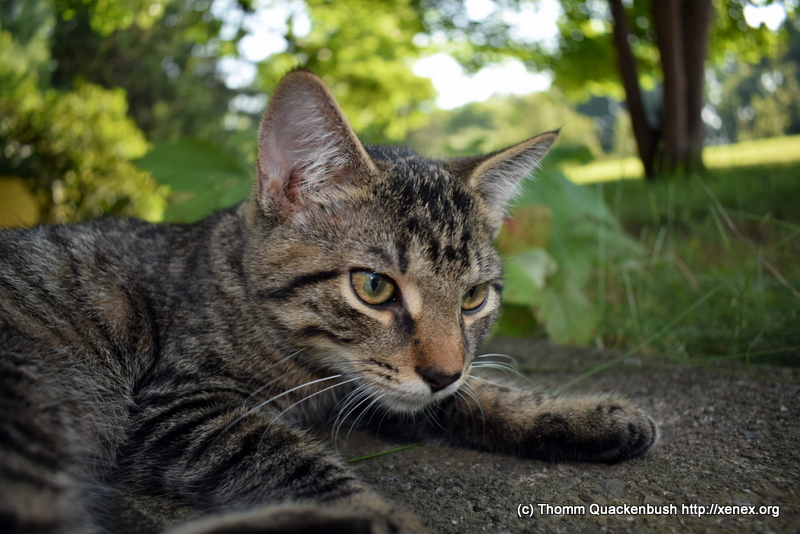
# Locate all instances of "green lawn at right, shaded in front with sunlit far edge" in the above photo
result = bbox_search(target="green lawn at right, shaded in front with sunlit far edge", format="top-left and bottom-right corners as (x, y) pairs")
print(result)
(569, 136), (800, 365)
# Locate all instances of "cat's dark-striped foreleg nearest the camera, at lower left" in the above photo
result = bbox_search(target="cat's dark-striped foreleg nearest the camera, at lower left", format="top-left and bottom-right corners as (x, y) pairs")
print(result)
(120, 386), (424, 534)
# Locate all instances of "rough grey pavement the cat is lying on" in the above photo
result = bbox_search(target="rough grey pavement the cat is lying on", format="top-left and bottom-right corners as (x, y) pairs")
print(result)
(112, 340), (800, 533)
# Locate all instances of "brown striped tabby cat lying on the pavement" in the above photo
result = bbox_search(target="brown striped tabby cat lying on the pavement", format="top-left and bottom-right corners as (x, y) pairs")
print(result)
(0, 71), (657, 533)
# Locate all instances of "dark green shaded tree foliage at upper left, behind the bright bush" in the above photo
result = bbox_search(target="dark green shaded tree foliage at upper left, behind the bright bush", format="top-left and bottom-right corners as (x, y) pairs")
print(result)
(50, 0), (241, 142)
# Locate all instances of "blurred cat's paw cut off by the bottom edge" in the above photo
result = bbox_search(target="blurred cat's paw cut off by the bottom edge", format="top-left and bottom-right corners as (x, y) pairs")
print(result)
(167, 503), (425, 534)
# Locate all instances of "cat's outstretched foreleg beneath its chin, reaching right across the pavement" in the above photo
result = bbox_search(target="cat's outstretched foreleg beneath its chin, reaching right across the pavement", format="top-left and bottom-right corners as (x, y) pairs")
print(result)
(431, 381), (658, 462)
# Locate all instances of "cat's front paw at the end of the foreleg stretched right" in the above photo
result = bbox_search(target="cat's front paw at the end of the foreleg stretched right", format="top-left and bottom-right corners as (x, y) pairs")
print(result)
(526, 397), (658, 462)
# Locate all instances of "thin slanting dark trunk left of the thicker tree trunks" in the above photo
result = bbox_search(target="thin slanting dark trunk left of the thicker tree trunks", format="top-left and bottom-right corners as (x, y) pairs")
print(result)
(609, 0), (658, 178)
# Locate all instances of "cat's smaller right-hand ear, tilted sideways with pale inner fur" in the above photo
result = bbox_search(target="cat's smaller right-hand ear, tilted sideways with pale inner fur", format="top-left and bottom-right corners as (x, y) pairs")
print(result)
(457, 131), (558, 231)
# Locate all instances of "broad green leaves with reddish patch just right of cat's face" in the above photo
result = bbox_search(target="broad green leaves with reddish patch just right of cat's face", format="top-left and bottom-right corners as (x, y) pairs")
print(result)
(497, 162), (641, 345)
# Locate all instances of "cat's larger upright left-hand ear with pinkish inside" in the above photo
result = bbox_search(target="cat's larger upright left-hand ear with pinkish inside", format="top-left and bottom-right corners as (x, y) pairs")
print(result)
(257, 71), (375, 219)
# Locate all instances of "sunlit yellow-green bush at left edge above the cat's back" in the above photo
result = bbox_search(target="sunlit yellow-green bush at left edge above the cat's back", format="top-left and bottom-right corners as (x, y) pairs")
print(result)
(0, 31), (165, 222)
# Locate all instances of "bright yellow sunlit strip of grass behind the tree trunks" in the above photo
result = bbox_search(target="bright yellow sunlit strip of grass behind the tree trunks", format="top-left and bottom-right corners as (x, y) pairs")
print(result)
(564, 135), (800, 184)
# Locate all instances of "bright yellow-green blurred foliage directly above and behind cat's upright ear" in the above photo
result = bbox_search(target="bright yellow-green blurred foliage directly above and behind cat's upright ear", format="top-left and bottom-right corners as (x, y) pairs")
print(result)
(260, 0), (434, 142)
